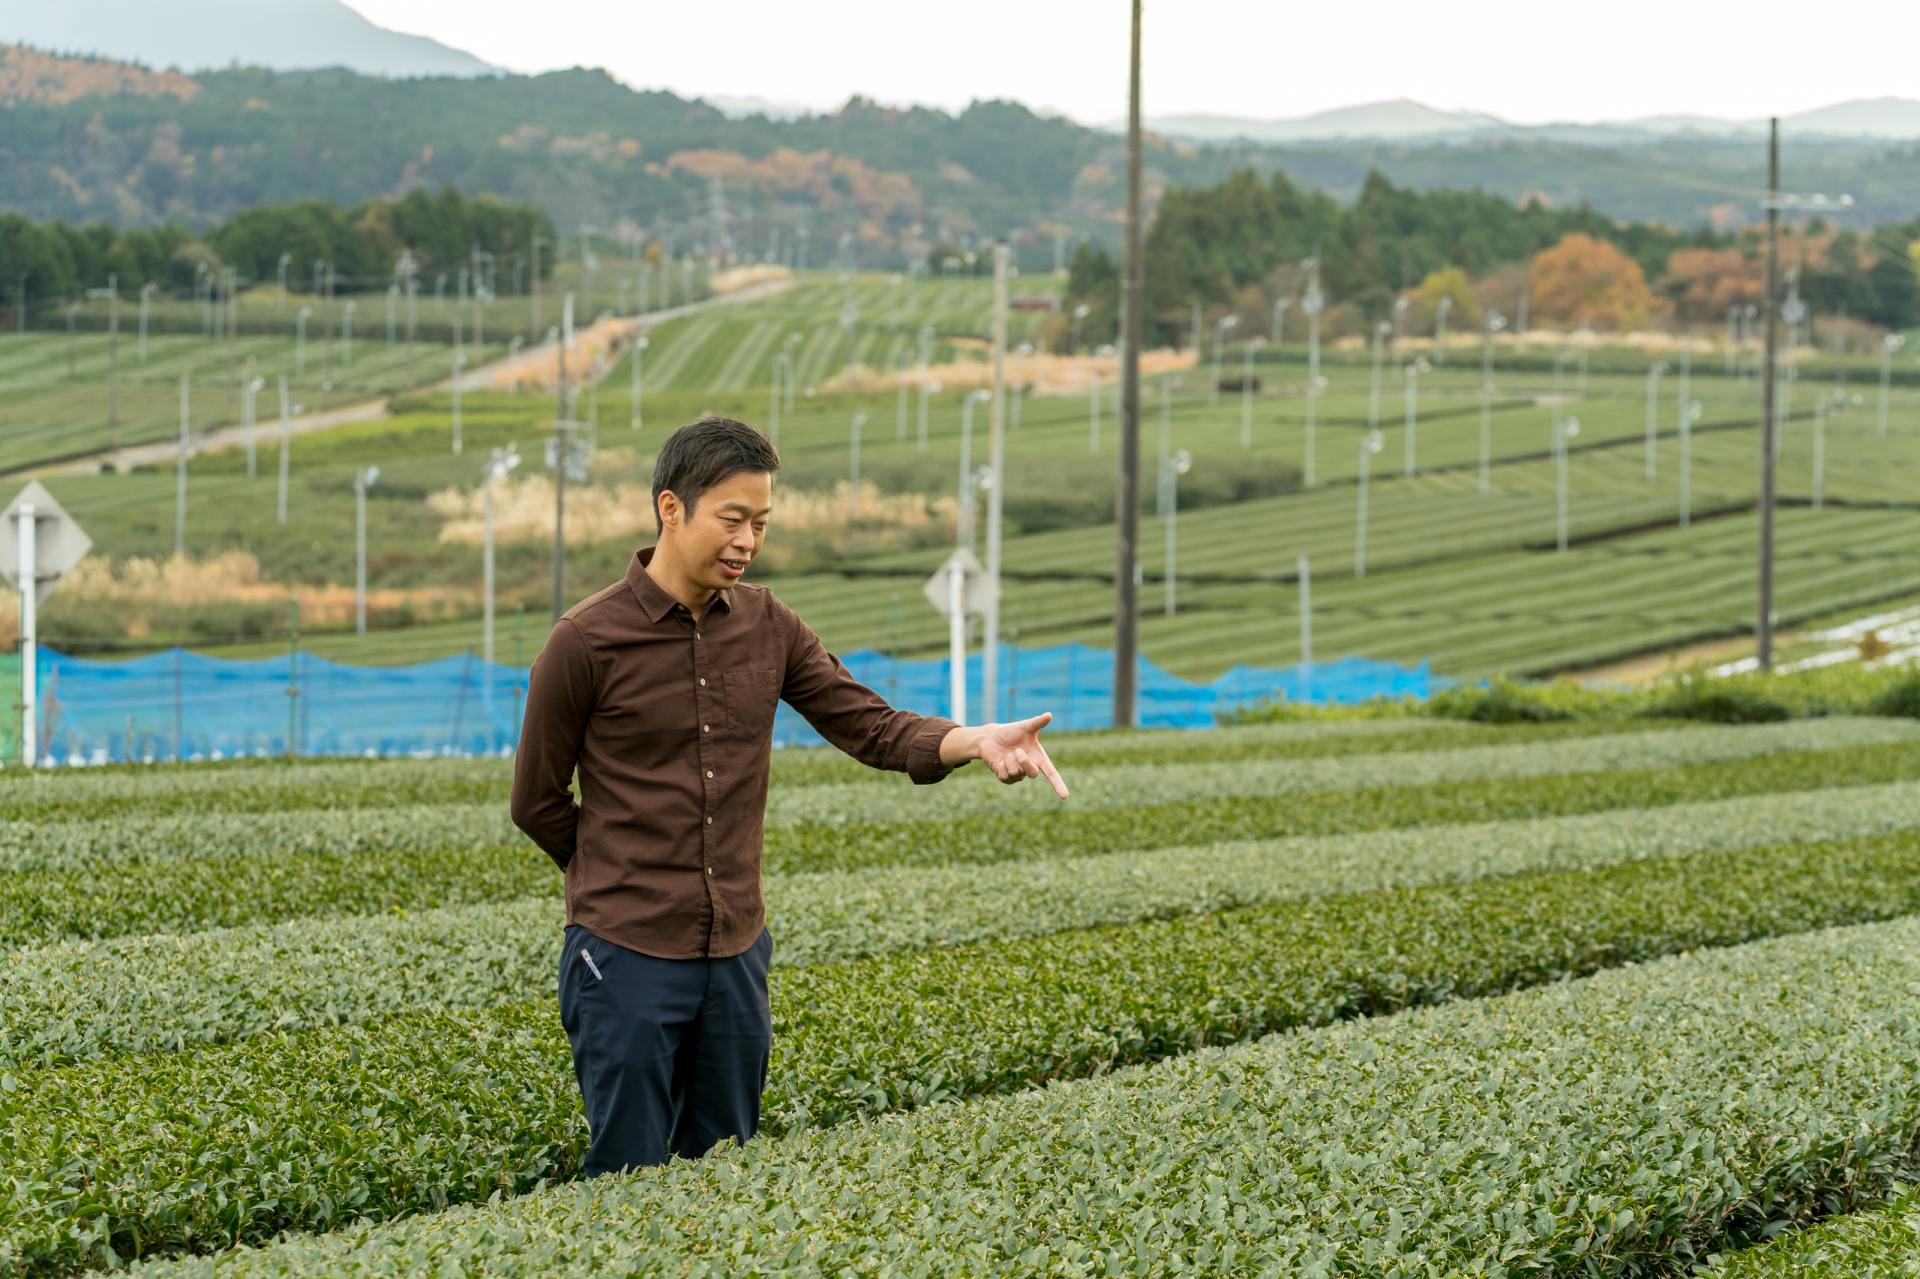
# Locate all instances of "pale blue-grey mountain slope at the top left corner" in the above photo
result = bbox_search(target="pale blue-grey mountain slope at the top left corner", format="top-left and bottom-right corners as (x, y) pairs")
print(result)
(0, 0), (495, 77)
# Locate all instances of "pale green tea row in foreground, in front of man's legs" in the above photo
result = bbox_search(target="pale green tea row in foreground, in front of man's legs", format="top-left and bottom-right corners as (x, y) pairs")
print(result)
(123, 906), (1920, 1279)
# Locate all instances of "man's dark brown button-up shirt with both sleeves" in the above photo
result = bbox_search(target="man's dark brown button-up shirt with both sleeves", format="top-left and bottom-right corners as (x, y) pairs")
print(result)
(511, 545), (958, 958)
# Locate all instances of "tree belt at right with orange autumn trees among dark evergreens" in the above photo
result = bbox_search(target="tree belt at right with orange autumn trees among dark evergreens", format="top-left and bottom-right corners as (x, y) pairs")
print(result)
(1068, 169), (1920, 344)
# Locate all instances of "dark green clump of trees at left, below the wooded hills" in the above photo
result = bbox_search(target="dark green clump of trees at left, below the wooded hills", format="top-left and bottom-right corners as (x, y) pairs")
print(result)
(0, 188), (555, 307)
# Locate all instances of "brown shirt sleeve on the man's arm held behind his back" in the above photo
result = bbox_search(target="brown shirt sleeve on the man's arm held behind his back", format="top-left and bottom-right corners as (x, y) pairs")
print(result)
(511, 616), (595, 870)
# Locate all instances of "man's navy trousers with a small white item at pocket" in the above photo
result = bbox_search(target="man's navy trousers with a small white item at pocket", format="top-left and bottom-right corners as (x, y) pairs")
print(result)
(561, 924), (774, 1177)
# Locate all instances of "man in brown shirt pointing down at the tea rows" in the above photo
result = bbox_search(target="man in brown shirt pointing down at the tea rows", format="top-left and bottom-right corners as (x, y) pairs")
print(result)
(511, 417), (1068, 1177)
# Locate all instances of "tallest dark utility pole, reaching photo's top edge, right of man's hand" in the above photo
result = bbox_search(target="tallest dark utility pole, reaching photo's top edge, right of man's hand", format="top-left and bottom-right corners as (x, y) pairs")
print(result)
(1114, 0), (1142, 728)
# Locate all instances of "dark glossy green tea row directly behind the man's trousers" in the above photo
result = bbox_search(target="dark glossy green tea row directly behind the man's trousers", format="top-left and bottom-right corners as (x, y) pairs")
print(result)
(0, 835), (1920, 1273)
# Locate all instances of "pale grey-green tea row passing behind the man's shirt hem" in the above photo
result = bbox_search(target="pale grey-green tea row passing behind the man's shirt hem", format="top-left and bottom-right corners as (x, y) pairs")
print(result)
(11, 782), (1920, 1070)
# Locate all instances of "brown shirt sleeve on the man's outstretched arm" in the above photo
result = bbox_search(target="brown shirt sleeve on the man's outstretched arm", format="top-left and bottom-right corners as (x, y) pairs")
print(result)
(774, 601), (960, 785)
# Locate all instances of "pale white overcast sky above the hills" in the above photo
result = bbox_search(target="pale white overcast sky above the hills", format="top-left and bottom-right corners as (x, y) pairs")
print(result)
(349, 0), (1920, 123)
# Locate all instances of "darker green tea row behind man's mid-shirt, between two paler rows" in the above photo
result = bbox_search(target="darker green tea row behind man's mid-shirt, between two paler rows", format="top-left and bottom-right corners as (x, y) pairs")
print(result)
(11, 730), (1920, 947)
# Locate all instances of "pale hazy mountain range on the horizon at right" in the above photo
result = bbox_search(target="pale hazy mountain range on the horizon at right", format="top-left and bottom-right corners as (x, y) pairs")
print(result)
(1128, 98), (1920, 146)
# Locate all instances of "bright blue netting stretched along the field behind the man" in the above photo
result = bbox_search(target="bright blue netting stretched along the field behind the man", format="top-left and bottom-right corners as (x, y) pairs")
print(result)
(6, 643), (1436, 764)
